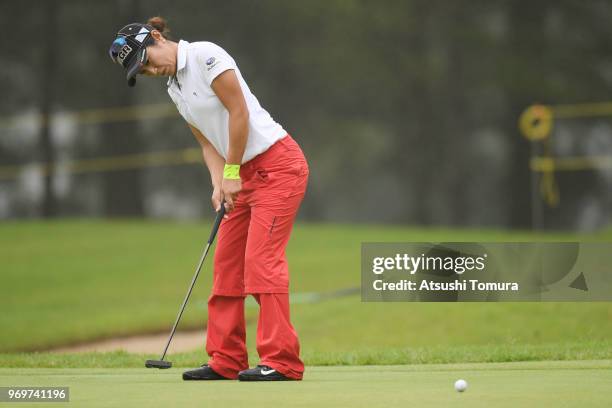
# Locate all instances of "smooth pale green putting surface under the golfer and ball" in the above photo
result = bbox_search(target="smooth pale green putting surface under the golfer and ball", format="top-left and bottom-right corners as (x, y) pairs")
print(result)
(0, 360), (612, 408)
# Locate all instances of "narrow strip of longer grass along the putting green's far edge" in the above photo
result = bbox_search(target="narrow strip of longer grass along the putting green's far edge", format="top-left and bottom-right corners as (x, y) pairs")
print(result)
(0, 340), (612, 368)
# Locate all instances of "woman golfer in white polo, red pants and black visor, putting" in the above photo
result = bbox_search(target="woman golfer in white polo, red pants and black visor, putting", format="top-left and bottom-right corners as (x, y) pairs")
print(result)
(110, 17), (308, 381)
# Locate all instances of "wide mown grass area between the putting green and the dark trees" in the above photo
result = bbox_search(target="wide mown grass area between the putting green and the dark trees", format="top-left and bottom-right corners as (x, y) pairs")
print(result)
(0, 220), (612, 367)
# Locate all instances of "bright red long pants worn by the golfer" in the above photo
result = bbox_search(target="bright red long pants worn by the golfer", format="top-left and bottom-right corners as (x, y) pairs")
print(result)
(206, 136), (308, 379)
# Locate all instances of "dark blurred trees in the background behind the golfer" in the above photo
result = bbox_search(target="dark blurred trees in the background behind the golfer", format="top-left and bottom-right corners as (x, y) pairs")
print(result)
(0, 0), (612, 230)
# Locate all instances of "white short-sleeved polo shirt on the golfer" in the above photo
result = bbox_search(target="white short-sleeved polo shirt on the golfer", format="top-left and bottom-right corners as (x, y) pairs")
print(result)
(168, 40), (287, 163)
